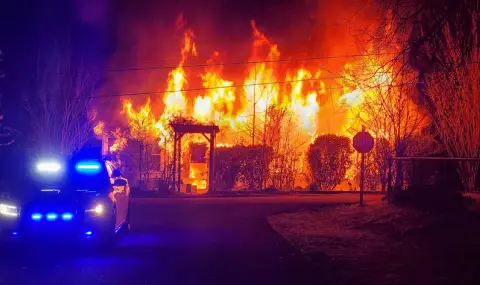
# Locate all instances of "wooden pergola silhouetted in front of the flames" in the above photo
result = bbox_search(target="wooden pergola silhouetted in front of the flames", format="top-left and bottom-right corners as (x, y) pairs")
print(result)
(170, 123), (220, 192)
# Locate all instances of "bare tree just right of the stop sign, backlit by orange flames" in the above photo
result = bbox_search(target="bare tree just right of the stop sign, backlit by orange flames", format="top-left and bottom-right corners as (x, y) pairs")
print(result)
(353, 54), (428, 194)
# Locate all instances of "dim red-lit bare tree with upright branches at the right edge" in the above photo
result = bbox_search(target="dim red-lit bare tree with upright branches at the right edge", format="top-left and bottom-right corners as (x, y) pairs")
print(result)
(424, 22), (480, 191)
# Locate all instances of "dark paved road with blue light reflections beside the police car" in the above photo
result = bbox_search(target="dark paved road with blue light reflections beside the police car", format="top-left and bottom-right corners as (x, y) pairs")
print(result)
(0, 194), (379, 285)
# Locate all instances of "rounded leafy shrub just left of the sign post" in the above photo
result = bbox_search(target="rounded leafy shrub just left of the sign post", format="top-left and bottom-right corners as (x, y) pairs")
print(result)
(308, 134), (353, 190)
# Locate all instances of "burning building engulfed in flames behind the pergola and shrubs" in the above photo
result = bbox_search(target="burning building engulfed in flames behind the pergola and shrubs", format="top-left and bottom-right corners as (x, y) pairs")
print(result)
(95, 1), (406, 191)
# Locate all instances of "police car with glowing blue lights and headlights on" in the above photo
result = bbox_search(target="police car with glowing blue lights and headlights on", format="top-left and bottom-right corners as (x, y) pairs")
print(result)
(0, 151), (130, 244)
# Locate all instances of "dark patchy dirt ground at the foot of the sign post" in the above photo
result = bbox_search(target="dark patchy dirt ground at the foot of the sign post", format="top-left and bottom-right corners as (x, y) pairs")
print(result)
(269, 202), (480, 285)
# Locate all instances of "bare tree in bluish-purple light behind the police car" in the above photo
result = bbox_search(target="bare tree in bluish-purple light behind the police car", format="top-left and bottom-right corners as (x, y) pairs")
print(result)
(23, 42), (100, 154)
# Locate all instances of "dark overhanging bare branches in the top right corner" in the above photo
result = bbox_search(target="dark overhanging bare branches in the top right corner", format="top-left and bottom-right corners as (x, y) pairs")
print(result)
(371, 0), (480, 73)
